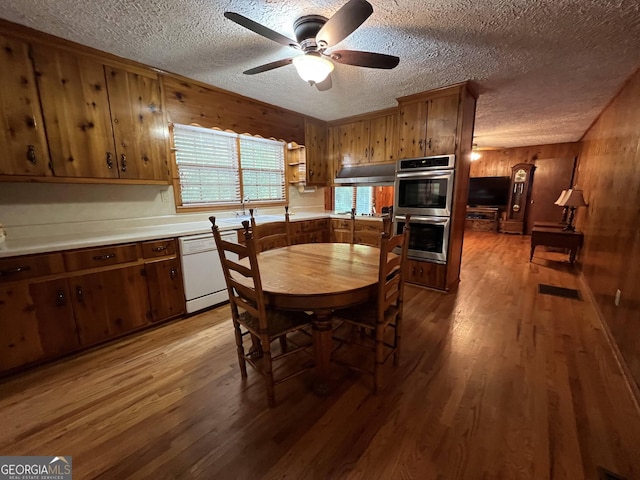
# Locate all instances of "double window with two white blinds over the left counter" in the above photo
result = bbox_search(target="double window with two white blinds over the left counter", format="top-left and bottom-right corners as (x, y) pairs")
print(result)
(173, 124), (286, 206)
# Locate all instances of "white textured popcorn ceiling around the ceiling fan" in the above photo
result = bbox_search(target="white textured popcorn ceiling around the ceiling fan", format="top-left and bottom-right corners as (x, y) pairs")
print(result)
(0, 0), (640, 147)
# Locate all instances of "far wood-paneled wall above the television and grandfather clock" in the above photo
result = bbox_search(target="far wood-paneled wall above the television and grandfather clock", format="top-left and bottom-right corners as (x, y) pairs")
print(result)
(470, 142), (580, 177)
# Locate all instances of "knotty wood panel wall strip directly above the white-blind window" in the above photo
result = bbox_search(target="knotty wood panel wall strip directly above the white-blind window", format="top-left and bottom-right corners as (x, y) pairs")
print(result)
(161, 75), (305, 145)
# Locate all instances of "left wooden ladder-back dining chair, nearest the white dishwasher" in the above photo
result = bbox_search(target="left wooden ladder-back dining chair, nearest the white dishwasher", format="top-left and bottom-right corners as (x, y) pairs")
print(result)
(209, 217), (313, 407)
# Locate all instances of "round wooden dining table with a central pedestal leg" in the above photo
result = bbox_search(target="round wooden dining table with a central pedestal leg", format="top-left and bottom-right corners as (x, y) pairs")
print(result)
(239, 243), (380, 393)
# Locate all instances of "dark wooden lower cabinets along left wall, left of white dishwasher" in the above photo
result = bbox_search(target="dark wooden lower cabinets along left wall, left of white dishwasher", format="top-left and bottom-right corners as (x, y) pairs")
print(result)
(0, 239), (185, 374)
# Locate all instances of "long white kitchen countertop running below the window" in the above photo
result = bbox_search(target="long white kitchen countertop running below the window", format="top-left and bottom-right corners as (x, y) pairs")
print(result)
(0, 212), (381, 258)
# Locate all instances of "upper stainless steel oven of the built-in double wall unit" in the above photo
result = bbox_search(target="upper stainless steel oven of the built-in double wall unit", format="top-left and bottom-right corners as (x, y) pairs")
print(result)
(394, 155), (455, 217)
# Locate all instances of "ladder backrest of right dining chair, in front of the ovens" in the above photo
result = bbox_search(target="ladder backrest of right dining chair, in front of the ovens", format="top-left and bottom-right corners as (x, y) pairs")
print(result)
(378, 215), (410, 322)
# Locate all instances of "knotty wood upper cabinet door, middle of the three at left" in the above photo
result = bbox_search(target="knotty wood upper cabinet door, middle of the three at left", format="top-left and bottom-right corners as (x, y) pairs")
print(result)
(33, 45), (118, 178)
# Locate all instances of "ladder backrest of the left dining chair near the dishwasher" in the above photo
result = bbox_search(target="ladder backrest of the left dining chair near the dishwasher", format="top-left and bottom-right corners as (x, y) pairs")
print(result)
(209, 217), (267, 331)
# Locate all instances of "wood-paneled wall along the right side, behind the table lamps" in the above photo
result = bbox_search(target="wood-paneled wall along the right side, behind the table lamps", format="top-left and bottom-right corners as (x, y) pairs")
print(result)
(576, 71), (640, 396)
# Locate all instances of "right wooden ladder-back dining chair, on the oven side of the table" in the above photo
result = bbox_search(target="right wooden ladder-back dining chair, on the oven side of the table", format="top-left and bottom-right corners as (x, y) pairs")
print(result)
(333, 219), (409, 393)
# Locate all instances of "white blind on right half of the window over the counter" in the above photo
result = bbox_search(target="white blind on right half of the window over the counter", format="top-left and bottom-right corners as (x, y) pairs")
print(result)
(240, 135), (285, 201)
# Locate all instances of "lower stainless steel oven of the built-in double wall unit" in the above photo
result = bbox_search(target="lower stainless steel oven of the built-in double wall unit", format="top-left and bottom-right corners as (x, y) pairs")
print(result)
(393, 215), (451, 263)
